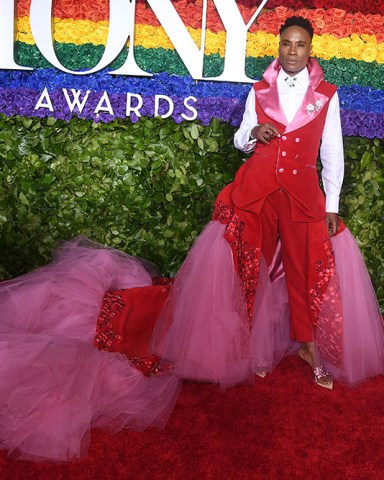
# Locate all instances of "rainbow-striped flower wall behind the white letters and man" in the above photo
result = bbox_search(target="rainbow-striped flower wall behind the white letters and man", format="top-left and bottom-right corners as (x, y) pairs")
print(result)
(0, 0), (384, 138)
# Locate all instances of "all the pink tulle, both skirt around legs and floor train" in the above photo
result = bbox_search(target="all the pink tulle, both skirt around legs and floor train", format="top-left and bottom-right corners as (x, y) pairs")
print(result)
(0, 222), (384, 461)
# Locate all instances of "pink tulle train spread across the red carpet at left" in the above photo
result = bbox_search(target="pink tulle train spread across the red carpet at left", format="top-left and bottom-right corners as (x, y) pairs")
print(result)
(0, 240), (180, 461)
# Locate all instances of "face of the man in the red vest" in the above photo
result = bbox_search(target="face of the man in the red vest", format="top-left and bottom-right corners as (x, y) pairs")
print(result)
(279, 26), (311, 77)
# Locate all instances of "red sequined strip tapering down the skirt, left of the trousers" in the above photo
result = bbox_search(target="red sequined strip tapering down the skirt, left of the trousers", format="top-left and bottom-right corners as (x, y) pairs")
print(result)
(212, 201), (260, 323)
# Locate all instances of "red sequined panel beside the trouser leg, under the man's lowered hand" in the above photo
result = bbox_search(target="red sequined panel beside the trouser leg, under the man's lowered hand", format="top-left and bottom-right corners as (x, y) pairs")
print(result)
(310, 237), (343, 365)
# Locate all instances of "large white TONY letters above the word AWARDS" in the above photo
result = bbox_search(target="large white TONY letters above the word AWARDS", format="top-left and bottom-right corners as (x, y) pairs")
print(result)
(0, 0), (268, 83)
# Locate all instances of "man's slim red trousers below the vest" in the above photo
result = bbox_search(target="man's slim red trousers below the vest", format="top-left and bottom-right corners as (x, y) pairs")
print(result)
(260, 189), (323, 342)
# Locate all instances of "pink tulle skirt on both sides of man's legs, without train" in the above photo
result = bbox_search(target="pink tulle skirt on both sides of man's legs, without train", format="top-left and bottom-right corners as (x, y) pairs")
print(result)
(153, 222), (384, 387)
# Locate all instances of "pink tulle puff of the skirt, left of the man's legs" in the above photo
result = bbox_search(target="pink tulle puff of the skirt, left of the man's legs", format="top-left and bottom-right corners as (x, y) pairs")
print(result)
(153, 222), (252, 386)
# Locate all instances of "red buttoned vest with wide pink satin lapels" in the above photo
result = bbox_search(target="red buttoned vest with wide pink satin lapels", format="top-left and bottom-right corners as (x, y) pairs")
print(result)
(232, 80), (336, 222)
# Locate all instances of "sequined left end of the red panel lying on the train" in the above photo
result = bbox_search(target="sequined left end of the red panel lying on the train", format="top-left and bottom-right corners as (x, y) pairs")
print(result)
(95, 291), (124, 351)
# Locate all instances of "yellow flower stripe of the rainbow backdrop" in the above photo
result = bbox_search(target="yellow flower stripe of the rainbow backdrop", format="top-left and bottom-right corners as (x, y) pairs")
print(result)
(17, 17), (384, 63)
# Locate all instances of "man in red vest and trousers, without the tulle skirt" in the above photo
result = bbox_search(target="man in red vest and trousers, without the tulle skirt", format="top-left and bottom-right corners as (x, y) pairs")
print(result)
(231, 17), (344, 388)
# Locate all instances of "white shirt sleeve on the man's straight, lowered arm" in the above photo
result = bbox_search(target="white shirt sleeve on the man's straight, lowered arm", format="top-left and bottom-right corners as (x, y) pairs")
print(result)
(320, 92), (344, 213)
